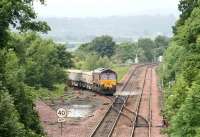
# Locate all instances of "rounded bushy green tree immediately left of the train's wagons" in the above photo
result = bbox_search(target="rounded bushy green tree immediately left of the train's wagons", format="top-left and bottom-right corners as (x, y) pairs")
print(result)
(21, 33), (73, 89)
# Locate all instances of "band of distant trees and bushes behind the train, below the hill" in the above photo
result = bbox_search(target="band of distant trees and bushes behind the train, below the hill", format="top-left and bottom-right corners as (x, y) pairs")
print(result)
(74, 36), (169, 70)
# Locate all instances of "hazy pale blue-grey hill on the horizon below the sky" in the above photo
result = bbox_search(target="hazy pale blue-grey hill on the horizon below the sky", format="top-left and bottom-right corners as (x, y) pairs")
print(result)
(41, 15), (176, 42)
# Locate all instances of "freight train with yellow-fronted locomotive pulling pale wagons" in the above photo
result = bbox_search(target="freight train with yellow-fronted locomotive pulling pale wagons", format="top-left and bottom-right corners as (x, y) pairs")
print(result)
(67, 68), (117, 95)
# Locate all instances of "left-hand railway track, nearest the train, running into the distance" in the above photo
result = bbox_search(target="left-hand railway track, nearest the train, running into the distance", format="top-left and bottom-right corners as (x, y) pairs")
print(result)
(90, 65), (146, 137)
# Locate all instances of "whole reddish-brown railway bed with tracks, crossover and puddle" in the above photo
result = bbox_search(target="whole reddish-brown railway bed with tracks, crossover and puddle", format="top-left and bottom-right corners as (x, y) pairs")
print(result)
(36, 64), (165, 137)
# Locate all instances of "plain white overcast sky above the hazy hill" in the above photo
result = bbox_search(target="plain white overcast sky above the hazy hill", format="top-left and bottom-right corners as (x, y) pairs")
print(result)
(34, 0), (179, 17)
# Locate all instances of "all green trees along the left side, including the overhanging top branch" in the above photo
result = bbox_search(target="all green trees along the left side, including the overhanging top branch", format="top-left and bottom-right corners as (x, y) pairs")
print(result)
(0, 0), (72, 137)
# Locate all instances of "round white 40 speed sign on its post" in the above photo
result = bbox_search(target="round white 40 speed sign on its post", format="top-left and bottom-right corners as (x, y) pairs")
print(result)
(56, 108), (67, 136)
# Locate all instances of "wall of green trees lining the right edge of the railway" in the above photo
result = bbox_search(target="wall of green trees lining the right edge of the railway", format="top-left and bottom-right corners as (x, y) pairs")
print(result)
(159, 0), (200, 137)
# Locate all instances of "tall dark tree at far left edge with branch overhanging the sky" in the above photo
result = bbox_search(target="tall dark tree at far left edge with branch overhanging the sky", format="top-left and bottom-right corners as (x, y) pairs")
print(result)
(0, 0), (50, 137)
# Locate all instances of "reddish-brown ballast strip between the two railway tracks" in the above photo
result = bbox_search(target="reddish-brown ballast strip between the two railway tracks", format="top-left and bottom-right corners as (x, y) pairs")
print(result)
(112, 66), (147, 137)
